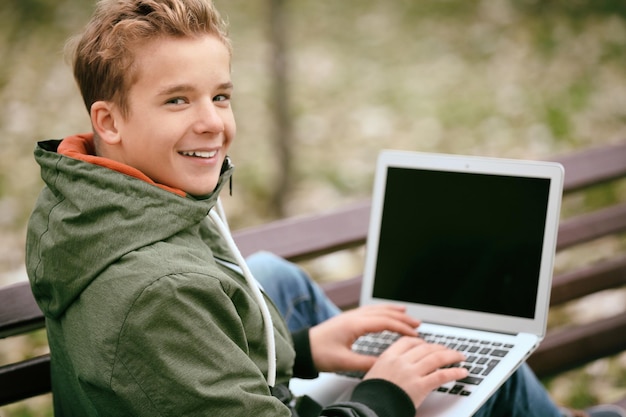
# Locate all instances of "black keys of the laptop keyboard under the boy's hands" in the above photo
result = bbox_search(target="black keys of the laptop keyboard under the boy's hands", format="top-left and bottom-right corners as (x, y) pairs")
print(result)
(342, 331), (513, 396)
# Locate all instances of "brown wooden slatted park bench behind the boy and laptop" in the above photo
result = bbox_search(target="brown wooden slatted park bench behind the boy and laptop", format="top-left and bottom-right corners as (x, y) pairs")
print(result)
(0, 143), (626, 405)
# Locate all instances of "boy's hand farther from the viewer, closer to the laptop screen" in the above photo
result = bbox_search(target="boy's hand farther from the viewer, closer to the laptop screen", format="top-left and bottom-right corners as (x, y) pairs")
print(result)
(309, 304), (420, 372)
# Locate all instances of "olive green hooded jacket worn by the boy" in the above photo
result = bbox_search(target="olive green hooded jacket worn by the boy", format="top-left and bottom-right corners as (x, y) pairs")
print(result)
(26, 137), (414, 417)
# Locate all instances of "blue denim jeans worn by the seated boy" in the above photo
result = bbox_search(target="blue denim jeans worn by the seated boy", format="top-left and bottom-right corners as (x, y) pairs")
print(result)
(247, 252), (561, 417)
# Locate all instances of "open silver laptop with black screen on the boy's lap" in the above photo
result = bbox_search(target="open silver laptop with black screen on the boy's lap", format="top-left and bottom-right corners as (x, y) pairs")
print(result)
(296, 150), (563, 417)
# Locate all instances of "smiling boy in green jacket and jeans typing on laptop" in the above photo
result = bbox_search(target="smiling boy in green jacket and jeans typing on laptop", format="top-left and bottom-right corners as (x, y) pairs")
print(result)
(27, 0), (624, 417)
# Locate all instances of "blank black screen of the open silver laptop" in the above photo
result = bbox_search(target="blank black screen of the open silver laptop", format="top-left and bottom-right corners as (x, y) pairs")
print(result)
(373, 168), (550, 318)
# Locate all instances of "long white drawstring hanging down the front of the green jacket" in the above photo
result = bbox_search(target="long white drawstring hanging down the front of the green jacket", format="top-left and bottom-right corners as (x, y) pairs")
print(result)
(209, 199), (276, 387)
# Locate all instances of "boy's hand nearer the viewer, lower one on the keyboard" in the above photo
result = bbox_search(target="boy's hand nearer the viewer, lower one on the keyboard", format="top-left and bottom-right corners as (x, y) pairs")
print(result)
(363, 337), (467, 408)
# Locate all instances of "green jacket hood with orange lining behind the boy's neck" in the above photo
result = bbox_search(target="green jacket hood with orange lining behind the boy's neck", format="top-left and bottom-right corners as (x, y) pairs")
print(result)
(26, 135), (233, 317)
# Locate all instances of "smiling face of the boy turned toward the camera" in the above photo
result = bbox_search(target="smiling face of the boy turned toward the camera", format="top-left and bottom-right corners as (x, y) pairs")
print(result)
(98, 35), (236, 196)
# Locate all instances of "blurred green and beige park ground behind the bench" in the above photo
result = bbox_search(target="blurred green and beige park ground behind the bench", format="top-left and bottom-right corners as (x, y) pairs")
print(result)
(0, 0), (626, 417)
